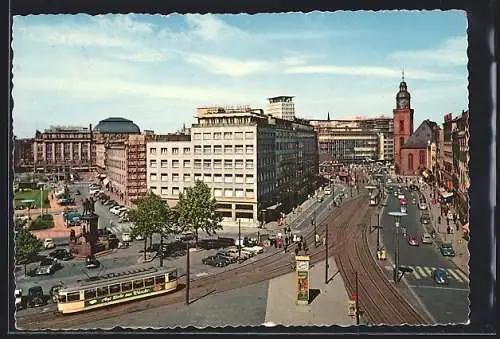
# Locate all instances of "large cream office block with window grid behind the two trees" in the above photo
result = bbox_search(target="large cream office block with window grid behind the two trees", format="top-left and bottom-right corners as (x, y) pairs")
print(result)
(147, 107), (318, 225)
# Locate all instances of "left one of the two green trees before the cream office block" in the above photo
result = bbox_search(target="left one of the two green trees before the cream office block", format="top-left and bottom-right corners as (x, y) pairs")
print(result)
(129, 192), (168, 260)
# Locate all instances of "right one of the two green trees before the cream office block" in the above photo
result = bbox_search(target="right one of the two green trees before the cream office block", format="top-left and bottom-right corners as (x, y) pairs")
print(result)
(177, 180), (222, 247)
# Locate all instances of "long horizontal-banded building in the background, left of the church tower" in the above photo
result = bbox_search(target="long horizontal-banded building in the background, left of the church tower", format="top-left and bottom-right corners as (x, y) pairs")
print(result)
(310, 117), (393, 163)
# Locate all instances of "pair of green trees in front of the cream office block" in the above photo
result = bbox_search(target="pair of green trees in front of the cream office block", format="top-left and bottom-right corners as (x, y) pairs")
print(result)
(129, 180), (222, 259)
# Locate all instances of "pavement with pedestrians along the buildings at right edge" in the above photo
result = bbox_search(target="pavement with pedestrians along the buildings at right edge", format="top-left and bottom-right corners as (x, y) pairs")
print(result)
(422, 188), (470, 274)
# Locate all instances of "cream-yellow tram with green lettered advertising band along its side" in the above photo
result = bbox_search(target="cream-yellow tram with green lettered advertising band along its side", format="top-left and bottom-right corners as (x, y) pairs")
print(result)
(56, 267), (178, 314)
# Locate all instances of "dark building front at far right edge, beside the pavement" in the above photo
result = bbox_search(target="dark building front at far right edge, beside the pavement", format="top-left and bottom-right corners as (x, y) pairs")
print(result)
(452, 111), (470, 224)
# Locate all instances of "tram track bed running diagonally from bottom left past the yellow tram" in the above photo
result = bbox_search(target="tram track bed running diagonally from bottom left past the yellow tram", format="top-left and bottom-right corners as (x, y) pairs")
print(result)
(16, 197), (366, 330)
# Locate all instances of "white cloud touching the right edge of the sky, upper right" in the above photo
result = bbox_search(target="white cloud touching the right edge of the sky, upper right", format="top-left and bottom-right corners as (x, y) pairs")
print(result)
(391, 36), (467, 66)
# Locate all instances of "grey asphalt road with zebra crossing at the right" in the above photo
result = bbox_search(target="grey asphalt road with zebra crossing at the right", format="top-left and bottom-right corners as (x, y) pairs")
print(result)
(381, 187), (469, 323)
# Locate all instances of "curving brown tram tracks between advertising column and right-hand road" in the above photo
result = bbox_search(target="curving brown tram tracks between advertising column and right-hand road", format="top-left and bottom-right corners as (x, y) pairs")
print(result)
(335, 210), (426, 325)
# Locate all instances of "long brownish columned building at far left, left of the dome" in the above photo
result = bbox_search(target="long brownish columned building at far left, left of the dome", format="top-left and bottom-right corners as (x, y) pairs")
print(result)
(33, 125), (93, 171)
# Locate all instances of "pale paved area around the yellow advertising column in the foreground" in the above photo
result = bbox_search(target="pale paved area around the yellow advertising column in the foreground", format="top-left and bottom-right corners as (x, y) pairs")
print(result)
(265, 257), (356, 326)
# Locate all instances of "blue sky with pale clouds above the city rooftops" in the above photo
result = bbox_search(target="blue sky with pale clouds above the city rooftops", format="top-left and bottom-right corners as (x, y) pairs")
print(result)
(12, 11), (468, 138)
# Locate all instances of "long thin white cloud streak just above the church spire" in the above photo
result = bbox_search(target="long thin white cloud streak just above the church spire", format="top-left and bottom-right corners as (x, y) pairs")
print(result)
(285, 65), (457, 81)
